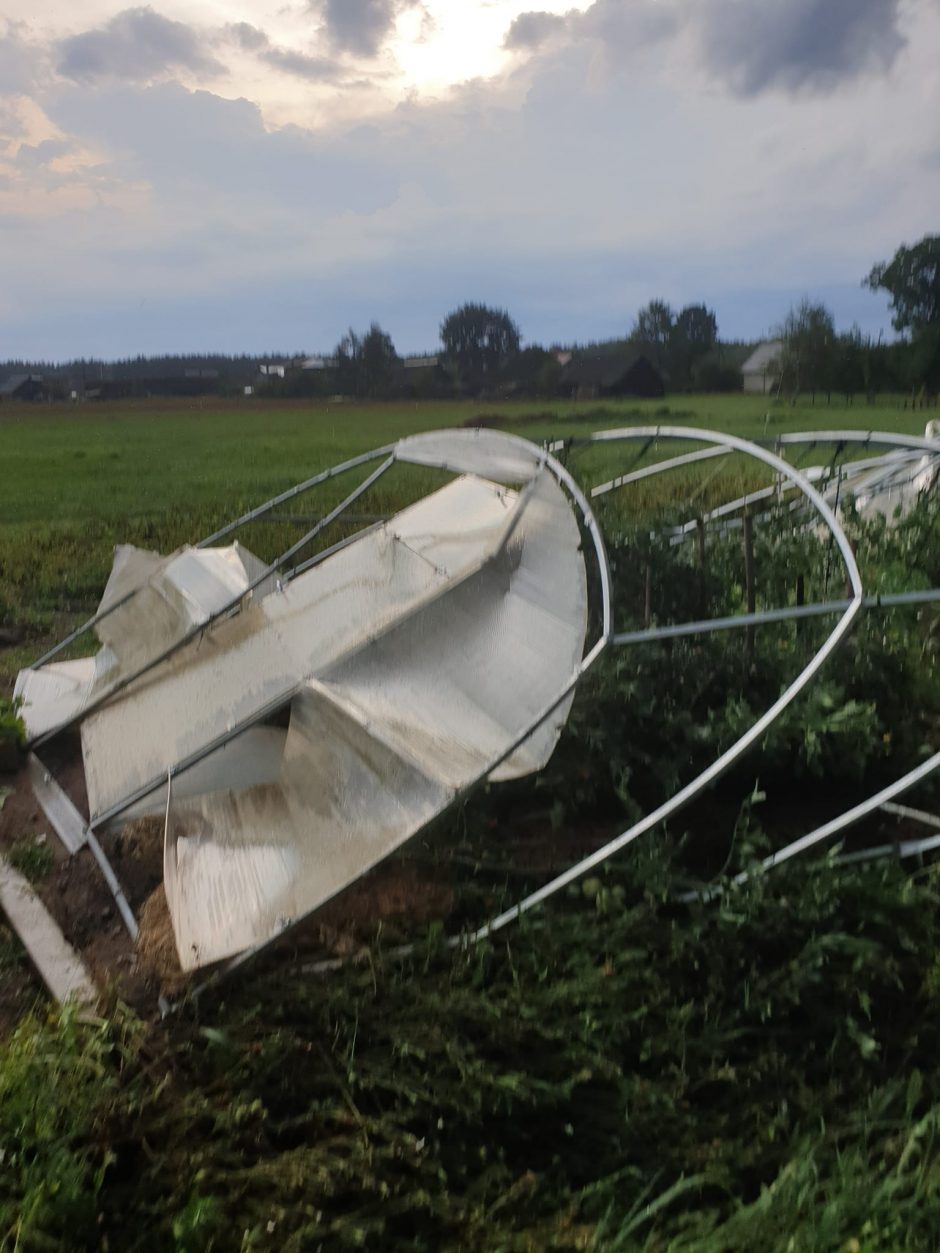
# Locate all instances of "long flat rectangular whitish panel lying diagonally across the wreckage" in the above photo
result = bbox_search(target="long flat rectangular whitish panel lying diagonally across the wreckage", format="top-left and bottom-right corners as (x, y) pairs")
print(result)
(81, 476), (518, 817)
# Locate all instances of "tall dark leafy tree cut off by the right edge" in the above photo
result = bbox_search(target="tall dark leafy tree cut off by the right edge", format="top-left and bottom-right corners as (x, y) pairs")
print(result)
(864, 236), (940, 391)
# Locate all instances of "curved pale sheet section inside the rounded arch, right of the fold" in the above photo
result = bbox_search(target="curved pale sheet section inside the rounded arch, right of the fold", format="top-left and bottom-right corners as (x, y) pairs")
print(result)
(318, 471), (587, 787)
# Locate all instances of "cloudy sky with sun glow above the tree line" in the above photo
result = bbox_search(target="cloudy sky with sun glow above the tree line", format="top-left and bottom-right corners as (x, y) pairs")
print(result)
(0, 0), (940, 360)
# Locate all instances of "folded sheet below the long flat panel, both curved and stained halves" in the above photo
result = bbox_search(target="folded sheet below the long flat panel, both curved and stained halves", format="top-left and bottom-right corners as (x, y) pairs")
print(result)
(165, 471), (587, 969)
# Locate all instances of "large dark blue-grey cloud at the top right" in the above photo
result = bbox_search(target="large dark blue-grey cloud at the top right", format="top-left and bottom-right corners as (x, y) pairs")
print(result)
(701, 0), (905, 95)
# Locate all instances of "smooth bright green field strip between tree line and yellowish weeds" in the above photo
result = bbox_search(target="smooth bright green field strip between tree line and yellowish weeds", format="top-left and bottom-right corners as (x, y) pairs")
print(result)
(0, 395), (925, 526)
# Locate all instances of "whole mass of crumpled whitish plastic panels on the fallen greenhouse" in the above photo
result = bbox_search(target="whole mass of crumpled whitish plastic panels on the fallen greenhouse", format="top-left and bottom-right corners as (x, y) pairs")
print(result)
(18, 431), (588, 970)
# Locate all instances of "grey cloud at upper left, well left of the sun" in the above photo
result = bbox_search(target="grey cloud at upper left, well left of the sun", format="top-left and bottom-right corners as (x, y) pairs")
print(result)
(58, 8), (223, 83)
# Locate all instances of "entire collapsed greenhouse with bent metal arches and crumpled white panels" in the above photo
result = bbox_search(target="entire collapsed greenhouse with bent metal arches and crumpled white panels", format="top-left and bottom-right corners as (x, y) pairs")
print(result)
(7, 424), (940, 1002)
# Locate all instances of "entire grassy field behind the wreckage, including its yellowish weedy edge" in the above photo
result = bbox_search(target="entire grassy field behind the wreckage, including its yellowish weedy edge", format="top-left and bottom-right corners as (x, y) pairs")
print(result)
(0, 395), (924, 687)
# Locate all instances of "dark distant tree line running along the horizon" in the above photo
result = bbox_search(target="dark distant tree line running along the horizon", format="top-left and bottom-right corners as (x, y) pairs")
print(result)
(0, 236), (940, 400)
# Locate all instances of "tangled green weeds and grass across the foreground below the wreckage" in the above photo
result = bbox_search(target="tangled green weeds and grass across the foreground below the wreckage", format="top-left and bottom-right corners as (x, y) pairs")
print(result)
(7, 862), (940, 1253)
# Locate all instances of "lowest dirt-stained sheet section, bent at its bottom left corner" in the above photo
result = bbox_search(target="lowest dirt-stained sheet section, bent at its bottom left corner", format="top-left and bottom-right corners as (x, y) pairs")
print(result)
(164, 688), (449, 970)
